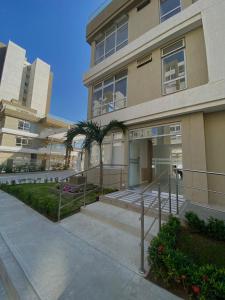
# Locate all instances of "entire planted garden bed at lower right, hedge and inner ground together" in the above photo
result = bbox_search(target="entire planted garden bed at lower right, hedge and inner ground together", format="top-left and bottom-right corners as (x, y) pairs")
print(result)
(148, 214), (225, 300)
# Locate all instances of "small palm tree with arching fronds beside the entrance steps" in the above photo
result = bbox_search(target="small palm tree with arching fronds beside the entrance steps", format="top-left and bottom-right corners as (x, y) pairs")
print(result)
(66, 120), (126, 189)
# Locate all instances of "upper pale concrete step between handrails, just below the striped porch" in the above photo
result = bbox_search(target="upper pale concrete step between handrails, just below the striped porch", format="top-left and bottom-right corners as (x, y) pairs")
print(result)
(81, 202), (161, 241)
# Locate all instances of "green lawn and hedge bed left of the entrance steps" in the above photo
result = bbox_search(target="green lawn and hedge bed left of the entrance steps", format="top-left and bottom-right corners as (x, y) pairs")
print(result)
(0, 183), (112, 221)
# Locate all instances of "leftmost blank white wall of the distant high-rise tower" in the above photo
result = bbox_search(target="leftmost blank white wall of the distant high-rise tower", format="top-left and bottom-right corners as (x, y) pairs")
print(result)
(0, 41), (26, 100)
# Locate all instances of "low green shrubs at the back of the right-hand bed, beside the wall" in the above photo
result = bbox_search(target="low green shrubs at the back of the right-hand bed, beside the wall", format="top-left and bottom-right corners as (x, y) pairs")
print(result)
(185, 212), (225, 241)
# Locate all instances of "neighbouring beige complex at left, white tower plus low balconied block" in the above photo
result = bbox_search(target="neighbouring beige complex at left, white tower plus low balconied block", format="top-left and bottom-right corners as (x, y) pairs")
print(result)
(0, 42), (80, 171)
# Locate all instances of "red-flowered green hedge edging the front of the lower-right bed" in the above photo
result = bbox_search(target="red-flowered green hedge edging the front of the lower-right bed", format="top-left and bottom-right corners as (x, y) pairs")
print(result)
(148, 217), (225, 300)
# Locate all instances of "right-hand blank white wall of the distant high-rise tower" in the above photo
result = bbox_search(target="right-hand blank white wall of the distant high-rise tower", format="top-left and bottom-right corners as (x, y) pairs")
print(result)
(28, 59), (50, 116)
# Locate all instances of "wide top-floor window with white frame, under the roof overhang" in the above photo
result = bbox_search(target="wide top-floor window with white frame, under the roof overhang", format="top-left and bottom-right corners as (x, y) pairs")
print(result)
(95, 17), (128, 64)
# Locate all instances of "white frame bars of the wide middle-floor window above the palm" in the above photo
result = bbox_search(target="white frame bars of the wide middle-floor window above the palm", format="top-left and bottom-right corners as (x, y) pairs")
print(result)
(92, 72), (128, 118)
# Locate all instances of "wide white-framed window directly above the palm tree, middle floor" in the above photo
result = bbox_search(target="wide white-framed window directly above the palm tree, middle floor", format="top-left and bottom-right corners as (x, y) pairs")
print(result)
(92, 71), (127, 117)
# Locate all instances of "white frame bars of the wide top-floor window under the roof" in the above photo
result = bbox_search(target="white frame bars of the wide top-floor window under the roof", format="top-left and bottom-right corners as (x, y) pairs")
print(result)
(94, 19), (128, 65)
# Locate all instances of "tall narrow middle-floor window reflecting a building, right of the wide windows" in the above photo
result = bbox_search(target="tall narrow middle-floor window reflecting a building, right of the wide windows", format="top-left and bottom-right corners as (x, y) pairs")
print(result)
(162, 39), (187, 95)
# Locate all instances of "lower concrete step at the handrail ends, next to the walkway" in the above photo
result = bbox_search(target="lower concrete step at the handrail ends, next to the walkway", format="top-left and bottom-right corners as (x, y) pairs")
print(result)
(60, 213), (149, 273)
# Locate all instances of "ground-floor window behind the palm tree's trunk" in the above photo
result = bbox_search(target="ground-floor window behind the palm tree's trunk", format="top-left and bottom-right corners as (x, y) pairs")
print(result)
(90, 132), (124, 167)
